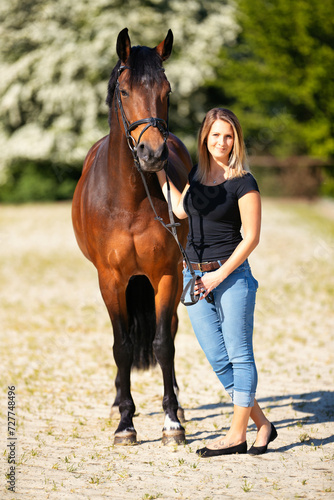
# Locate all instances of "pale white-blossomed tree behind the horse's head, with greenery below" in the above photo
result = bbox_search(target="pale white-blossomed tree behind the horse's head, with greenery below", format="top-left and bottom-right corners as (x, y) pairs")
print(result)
(0, 0), (237, 199)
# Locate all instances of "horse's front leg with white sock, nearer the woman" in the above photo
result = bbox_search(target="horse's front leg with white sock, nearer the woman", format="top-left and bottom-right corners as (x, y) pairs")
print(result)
(153, 275), (185, 444)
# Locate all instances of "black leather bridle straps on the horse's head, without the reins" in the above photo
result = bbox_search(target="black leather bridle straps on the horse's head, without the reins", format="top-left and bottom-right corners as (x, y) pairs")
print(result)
(115, 66), (169, 169)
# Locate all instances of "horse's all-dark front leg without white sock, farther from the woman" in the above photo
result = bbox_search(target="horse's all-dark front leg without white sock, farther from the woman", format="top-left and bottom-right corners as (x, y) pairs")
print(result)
(99, 275), (137, 445)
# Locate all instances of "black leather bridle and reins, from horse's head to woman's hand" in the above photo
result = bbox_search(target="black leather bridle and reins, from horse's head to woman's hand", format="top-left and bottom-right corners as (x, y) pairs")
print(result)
(115, 66), (213, 306)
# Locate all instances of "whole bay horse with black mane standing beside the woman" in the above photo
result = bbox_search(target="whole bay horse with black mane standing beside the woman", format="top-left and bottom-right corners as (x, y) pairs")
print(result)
(72, 28), (192, 445)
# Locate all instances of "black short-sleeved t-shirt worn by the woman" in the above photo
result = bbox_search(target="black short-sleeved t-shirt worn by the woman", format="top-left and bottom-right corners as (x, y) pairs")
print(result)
(183, 166), (259, 262)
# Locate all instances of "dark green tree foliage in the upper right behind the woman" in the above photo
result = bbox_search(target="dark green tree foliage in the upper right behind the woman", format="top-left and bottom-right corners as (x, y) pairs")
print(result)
(208, 0), (334, 158)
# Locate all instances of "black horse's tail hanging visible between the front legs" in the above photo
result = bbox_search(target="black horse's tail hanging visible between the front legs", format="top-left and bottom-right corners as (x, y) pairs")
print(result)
(126, 276), (156, 370)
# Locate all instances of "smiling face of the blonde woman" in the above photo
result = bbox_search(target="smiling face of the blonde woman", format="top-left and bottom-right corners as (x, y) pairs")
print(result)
(206, 120), (234, 165)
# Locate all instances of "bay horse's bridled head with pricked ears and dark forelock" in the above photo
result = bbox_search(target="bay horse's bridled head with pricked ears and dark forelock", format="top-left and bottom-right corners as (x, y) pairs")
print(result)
(107, 28), (173, 172)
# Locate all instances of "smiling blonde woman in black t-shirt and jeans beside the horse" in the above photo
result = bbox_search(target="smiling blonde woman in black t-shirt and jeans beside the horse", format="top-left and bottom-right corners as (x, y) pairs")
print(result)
(157, 108), (277, 457)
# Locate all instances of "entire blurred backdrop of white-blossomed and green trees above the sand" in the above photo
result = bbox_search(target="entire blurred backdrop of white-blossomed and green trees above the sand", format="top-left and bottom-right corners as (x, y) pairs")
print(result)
(0, 0), (334, 202)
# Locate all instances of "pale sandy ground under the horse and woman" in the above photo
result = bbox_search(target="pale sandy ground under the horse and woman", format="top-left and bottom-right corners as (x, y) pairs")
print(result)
(0, 200), (334, 500)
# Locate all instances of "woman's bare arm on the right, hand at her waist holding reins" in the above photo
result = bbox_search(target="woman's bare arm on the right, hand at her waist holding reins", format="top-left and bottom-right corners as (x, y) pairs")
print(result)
(196, 191), (261, 299)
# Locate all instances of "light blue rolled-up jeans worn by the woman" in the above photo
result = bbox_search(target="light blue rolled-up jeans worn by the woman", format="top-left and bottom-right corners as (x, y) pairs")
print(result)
(183, 260), (258, 408)
